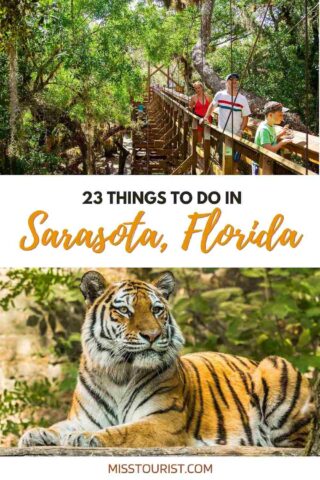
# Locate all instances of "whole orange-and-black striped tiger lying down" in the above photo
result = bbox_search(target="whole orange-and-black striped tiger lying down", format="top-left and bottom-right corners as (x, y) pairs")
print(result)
(19, 271), (315, 448)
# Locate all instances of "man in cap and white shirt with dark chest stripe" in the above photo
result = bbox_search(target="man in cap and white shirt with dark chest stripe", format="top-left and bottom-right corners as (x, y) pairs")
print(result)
(204, 73), (251, 173)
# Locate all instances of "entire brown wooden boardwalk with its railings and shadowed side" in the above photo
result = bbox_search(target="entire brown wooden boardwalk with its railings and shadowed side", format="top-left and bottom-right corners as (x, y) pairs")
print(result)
(132, 88), (319, 175)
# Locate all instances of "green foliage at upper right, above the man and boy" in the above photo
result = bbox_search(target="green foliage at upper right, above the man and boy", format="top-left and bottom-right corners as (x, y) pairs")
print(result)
(209, 0), (319, 132)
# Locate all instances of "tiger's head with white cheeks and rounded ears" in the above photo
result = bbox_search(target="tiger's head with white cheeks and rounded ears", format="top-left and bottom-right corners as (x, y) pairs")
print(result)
(80, 272), (184, 373)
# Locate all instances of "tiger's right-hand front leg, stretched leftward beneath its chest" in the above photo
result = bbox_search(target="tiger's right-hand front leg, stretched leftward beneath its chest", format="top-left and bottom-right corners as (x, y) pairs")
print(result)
(64, 415), (191, 448)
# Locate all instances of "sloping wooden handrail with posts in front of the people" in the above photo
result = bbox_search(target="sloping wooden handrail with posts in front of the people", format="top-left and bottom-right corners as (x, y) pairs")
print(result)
(151, 87), (316, 175)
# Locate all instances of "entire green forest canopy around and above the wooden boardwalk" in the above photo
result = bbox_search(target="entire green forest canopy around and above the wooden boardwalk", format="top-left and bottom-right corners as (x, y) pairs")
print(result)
(0, 0), (318, 173)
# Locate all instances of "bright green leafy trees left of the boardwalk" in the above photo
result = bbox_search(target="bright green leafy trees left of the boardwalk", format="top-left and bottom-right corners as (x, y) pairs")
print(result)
(0, 0), (144, 174)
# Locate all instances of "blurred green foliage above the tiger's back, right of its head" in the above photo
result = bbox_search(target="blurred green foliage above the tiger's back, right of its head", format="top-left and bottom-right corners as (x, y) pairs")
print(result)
(174, 268), (320, 371)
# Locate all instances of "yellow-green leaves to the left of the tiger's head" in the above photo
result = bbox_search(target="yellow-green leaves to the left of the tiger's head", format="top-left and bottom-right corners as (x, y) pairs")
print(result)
(0, 268), (84, 361)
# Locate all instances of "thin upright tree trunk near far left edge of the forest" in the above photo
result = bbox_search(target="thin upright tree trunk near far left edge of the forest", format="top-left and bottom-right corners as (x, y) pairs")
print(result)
(7, 41), (20, 173)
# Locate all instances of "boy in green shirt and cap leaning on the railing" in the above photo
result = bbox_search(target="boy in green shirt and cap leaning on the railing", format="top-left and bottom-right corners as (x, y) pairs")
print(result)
(252, 102), (291, 175)
